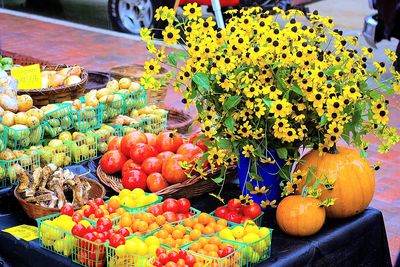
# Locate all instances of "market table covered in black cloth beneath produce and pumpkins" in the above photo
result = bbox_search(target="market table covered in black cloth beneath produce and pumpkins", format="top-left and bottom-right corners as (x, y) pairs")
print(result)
(0, 166), (392, 267)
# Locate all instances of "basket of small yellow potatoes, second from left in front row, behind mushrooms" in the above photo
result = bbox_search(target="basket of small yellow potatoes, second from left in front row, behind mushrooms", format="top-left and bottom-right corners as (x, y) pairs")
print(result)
(39, 139), (71, 167)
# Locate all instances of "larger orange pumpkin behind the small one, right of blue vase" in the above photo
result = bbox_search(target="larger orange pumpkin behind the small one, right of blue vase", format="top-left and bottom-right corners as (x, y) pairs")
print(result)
(296, 147), (375, 218)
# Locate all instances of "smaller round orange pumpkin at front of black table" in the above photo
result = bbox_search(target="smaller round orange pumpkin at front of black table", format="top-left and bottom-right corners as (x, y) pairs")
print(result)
(276, 196), (325, 236)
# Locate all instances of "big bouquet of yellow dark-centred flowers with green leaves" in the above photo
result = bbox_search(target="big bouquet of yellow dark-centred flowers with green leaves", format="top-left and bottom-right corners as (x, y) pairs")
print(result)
(141, 4), (400, 203)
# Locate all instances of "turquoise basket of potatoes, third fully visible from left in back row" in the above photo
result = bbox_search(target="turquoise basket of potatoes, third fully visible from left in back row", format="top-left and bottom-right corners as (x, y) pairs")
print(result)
(71, 105), (103, 132)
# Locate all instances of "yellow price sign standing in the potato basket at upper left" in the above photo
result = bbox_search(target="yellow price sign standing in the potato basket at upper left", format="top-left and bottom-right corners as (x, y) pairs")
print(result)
(11, 64), (42, 90)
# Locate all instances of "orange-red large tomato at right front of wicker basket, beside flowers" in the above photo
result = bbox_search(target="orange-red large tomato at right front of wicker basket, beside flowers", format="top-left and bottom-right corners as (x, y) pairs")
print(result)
(162, 154), (188, 184)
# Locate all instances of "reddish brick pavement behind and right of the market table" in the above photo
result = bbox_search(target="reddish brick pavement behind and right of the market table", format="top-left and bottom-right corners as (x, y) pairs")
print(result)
(0, 13), (400, 261)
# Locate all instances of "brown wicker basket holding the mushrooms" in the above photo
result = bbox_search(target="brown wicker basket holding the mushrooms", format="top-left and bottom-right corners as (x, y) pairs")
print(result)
(14, 178), (106, 219)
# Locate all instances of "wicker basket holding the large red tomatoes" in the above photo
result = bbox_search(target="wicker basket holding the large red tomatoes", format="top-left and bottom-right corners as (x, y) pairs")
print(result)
(97, 166), (236, 198)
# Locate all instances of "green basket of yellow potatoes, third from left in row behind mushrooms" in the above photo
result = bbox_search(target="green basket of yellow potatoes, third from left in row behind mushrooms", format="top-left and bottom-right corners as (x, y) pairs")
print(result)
(65, 133), (97, 164)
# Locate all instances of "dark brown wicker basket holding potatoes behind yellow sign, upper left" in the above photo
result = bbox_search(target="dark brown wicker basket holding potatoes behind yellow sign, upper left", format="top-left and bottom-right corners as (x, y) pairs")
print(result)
(18, 65), (88, 107)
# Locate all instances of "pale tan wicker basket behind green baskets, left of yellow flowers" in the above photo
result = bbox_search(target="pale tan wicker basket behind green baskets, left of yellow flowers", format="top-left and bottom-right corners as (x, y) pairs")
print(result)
(110, 64), (168, 105)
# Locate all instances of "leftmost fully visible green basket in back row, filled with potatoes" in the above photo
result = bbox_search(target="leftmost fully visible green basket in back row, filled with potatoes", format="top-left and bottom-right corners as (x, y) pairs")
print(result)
(3, 124), (44, 149)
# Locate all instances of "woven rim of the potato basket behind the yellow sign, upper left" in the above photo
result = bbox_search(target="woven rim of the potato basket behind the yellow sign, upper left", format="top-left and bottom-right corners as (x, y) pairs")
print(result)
(18, 64), (89, 95)
